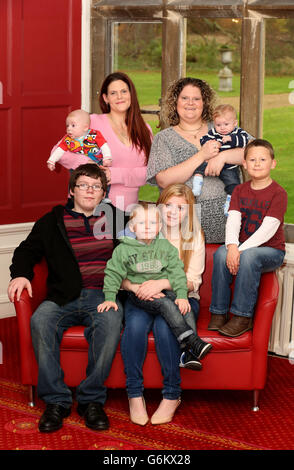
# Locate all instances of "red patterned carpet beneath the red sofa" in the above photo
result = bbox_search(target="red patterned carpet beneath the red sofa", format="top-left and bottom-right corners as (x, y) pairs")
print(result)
(0, 319), (294, 451)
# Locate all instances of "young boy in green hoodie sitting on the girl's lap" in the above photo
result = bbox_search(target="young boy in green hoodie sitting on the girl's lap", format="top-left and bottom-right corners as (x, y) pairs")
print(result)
(97, 203), (212, 370)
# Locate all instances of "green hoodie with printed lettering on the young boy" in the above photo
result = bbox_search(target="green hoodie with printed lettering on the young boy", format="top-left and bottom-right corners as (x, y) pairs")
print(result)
(103, 235), (188, 302)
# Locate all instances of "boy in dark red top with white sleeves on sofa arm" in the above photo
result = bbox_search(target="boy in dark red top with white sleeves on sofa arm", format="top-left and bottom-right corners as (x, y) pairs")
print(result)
(208, 139), (287, 337)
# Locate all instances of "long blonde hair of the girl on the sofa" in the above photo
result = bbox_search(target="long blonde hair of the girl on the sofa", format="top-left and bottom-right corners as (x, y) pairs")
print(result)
(156, 183), (204, 272)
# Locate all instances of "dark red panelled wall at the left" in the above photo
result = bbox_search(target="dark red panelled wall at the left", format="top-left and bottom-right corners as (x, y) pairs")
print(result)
(0, 0), (81, 224)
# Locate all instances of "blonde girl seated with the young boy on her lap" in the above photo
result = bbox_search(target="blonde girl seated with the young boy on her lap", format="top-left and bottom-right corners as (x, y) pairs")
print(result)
(121, 184), (205, 425)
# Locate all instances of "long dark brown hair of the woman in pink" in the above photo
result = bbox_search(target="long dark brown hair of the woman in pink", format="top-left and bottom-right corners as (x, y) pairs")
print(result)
(99, 72), (151, 164)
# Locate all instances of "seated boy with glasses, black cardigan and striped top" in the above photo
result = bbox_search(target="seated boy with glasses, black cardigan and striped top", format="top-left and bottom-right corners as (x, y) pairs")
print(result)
(8, 163), (125, 432)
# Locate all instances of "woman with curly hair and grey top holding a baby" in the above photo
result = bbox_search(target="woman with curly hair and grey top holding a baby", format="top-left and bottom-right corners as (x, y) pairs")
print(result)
(147, 77), (248, 243)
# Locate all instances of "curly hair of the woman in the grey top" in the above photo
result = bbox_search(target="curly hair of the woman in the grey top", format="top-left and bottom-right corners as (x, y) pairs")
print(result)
(160, 77), (215, 126)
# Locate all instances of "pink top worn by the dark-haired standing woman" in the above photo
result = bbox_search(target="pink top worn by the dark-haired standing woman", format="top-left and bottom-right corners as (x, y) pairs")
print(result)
(59, 114), (151, 210)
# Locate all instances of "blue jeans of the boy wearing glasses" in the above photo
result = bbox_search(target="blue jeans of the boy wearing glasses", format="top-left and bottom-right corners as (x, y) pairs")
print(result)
(31, 289), (123, 407)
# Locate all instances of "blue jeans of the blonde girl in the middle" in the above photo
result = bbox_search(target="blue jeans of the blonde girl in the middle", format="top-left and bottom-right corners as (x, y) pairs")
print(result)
(121, 298), (199, 400)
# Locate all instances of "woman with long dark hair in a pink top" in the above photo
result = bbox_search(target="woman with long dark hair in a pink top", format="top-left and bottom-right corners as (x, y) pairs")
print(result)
(60, 72), (152, 210)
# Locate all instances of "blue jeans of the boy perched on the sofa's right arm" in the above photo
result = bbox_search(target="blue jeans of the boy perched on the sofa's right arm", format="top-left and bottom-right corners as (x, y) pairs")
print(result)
(209, 245), (285, 318)
